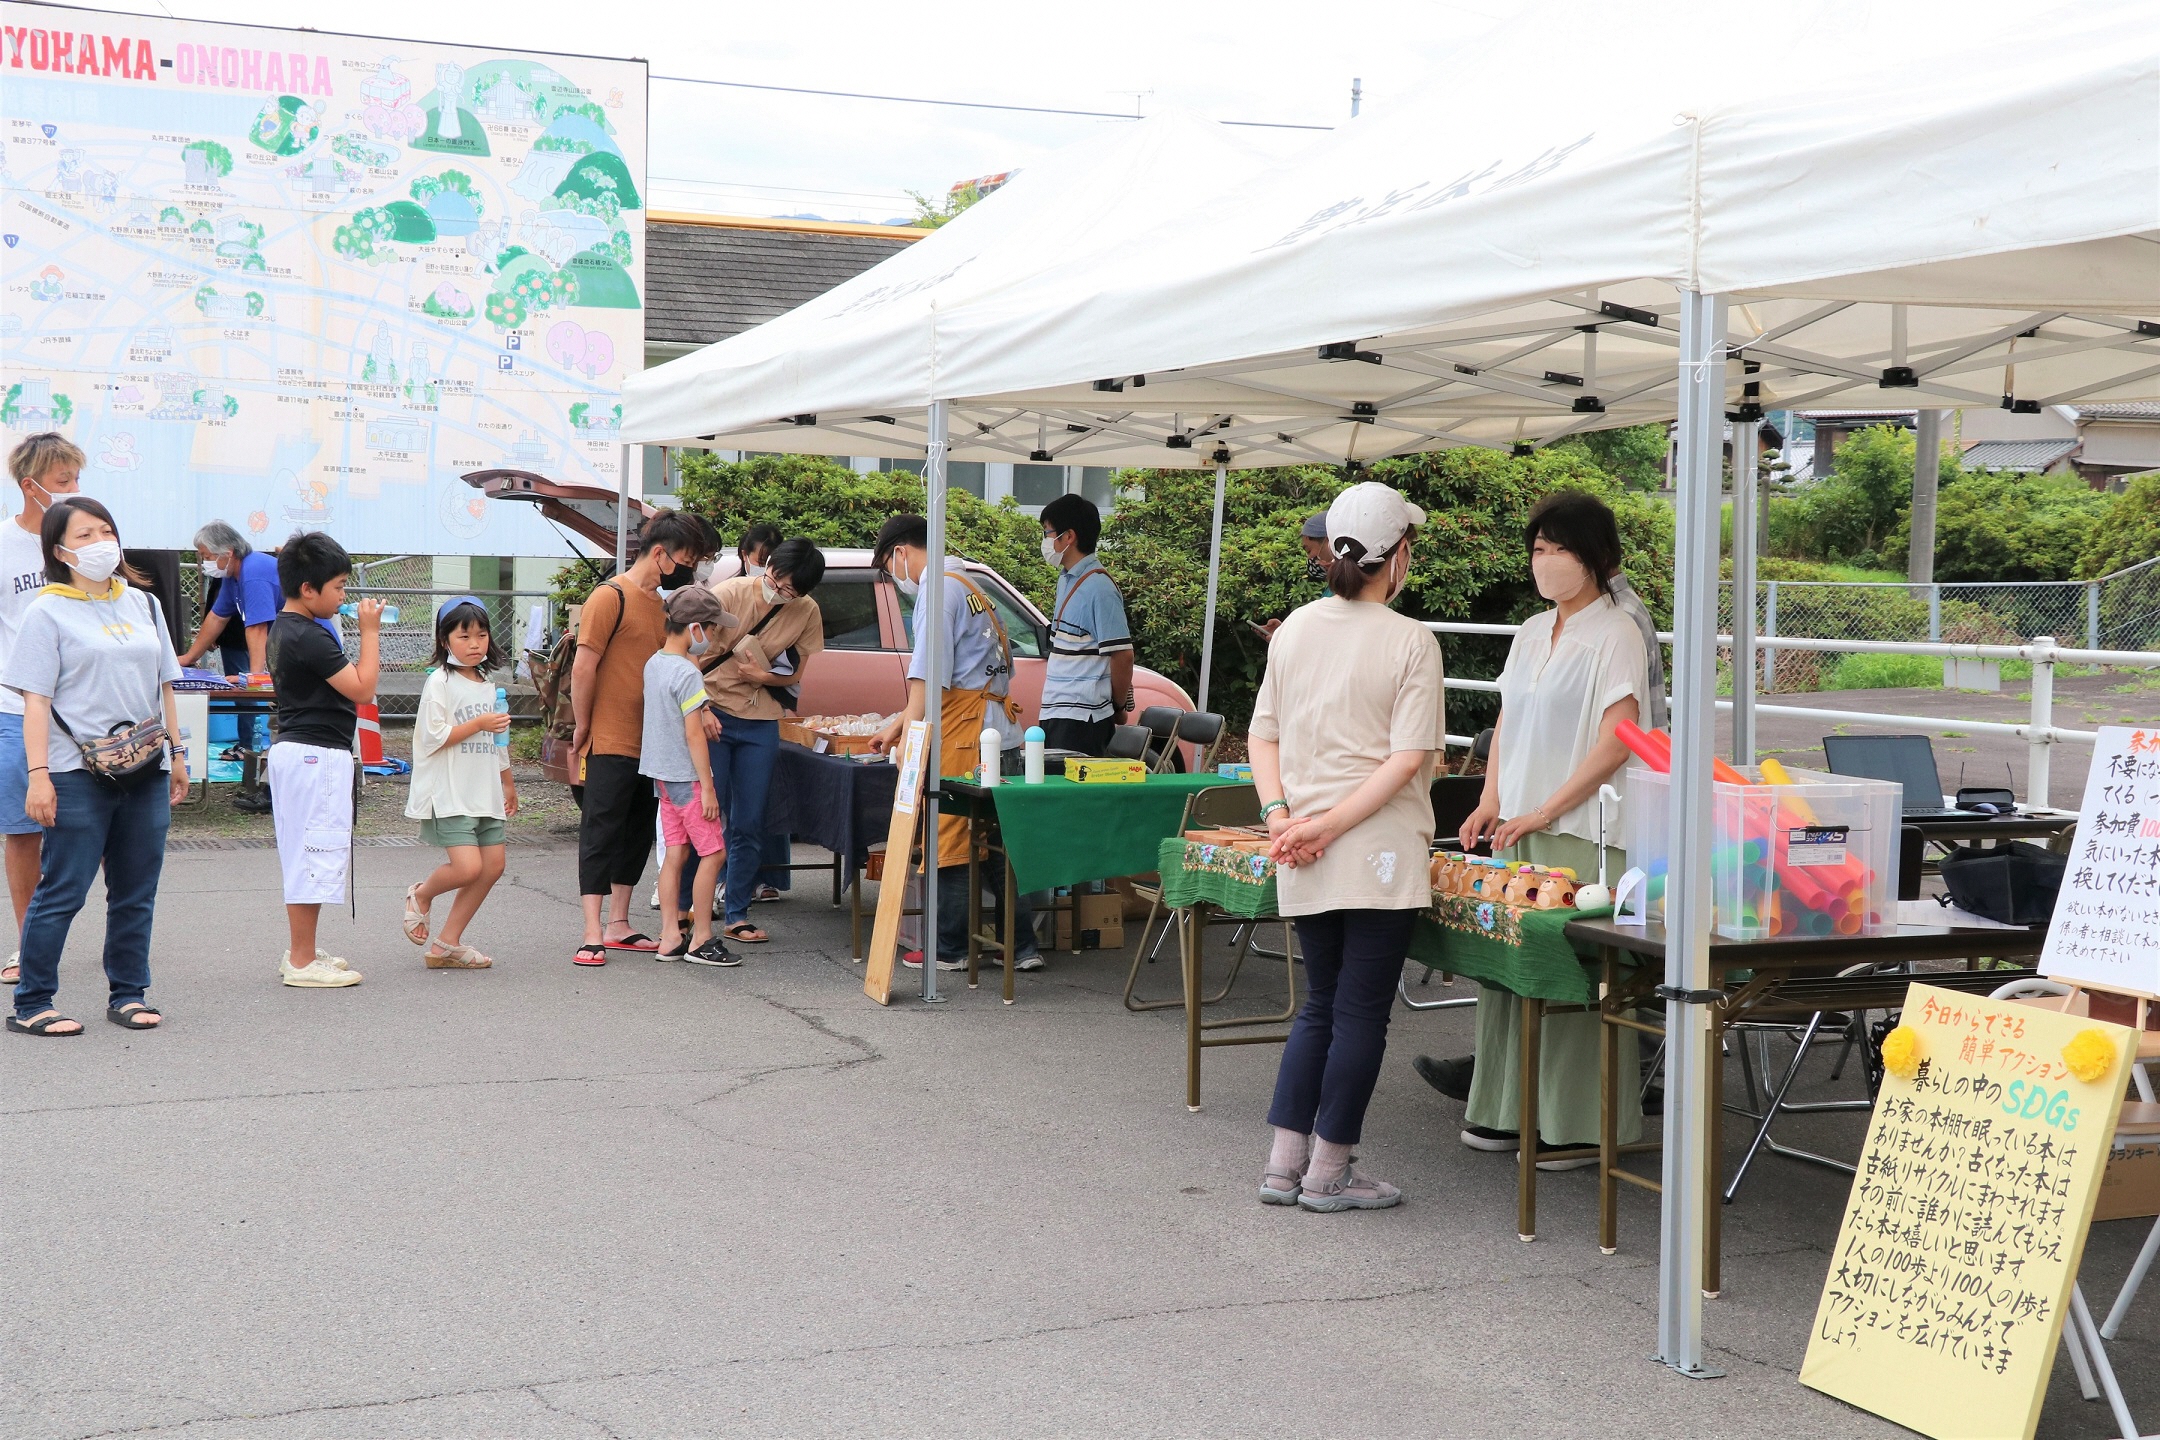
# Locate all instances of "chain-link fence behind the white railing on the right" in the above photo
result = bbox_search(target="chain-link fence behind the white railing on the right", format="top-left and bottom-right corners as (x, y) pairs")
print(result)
(1717, 559), (2160, 691)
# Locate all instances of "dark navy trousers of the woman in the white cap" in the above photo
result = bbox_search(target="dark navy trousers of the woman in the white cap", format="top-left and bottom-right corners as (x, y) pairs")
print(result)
(1268, 911), (1417, 1144)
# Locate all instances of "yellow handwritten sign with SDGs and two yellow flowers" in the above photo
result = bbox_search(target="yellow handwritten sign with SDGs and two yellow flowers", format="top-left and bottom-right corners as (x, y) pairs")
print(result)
(1799, 984), (2136, 1440)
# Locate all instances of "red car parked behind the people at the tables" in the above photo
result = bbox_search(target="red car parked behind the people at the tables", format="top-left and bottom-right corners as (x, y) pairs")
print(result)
(524, 548), (1192, 784)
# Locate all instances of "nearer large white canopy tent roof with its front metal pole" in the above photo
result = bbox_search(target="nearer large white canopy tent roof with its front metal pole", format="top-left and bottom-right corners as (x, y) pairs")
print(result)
(626, 0), (2160, 1373)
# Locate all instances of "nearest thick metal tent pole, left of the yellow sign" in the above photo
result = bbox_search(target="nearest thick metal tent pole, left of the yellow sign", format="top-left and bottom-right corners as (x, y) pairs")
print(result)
(1657, 289), (1726, 1377)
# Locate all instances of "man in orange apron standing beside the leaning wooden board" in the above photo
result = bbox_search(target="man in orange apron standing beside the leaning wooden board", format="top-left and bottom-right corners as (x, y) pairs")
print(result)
(873, 516), (1043, 969)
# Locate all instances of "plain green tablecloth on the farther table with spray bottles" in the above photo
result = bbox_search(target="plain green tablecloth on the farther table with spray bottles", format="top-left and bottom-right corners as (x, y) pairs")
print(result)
(966, 775), (1240, 894)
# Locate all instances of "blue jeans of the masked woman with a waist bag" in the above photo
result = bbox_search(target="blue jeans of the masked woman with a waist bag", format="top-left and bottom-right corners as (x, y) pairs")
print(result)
(15, 771), (173, 1019)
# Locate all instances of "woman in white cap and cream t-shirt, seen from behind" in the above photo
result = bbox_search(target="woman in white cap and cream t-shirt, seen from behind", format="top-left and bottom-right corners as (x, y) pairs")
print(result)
(1251, 481), (1445, 1211)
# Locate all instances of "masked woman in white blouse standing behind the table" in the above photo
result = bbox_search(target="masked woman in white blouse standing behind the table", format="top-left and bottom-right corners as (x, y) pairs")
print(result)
(1417, 490), (1650, 1170)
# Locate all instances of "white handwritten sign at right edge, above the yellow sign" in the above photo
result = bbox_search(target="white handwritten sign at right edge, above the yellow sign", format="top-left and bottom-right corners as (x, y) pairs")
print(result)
(2039, 725), (2160, 995)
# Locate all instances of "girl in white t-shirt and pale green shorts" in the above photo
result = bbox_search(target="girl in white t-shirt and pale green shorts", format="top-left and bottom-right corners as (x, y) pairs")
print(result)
(404, 596), (518, 969)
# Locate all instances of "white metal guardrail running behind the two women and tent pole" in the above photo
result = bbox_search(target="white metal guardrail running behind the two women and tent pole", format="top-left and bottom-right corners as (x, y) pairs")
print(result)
(1426, 620), (2160, 805)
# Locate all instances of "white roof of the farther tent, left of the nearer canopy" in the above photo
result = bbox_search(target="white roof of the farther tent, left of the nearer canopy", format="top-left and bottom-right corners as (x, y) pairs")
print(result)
(622, 112), (1261, 458)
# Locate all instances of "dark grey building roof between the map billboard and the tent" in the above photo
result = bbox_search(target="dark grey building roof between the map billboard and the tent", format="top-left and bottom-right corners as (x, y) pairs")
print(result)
(646, 212), (929, 345)
